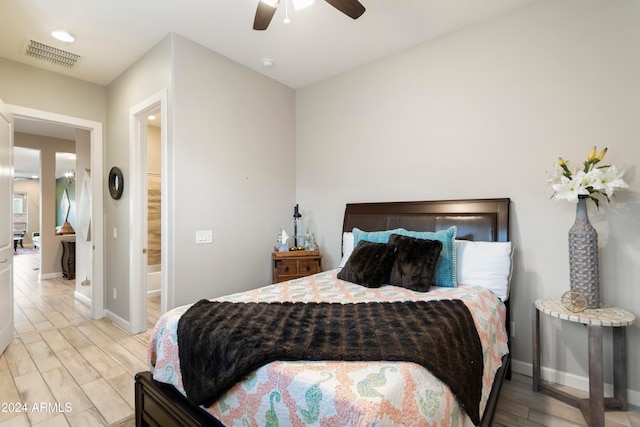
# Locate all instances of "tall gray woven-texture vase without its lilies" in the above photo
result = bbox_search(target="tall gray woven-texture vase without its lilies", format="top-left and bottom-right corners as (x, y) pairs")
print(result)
(569, 199), (600, 308)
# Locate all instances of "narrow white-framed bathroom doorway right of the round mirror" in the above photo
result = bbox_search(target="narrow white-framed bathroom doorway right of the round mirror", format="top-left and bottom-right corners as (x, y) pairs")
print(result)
(130, 90), (170, 334)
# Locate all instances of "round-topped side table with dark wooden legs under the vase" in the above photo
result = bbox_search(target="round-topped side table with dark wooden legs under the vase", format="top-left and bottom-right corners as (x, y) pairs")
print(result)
(532, 298), (635, 427)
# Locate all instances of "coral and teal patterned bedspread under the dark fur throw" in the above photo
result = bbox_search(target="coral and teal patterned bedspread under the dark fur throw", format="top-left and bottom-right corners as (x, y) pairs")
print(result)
(149, 270), (508, 427)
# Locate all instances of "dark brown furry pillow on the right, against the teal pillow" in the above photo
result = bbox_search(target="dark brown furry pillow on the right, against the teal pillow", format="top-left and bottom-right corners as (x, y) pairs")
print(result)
(389, 234), (442, 292)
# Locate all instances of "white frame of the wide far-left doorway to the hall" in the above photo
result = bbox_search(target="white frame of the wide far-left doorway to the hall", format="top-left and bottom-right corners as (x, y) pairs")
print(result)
(7, 104), (105, 319)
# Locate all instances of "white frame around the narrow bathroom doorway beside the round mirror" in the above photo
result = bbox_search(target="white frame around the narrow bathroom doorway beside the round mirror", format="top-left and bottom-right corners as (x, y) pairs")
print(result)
(129, 89), (171, 334)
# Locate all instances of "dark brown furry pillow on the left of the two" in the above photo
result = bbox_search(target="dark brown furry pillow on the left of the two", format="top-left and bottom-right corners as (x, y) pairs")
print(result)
(338, 240), (396, 288)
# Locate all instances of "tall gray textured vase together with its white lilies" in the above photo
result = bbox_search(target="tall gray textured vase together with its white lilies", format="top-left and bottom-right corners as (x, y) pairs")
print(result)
(547, 147), (628, 308)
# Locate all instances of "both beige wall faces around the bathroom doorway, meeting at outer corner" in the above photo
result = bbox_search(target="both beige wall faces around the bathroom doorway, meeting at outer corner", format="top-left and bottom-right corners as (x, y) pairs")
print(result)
(106, 35), (295, 321)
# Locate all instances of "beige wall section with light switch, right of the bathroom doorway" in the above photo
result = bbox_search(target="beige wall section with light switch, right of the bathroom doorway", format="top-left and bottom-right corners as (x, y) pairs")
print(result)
(169, 36), (295, 305)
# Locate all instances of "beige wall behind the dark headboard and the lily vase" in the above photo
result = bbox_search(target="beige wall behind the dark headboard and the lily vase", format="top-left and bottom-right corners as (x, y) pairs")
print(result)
(296, 0), (640, 404)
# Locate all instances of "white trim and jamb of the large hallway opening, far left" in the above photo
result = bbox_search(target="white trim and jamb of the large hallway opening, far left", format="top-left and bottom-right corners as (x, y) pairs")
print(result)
(8, 105), (104, 319)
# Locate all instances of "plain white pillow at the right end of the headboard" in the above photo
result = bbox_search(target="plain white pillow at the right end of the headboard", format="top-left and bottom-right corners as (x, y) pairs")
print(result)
(456, 240), (513, 301)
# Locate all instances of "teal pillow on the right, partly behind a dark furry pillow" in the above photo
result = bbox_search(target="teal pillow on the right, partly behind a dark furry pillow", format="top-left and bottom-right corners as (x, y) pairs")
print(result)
(394, 225), (458, 288)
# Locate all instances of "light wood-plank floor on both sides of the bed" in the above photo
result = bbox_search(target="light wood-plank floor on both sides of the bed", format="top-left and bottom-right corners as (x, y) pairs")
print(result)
(0, 255), (640, 427)
